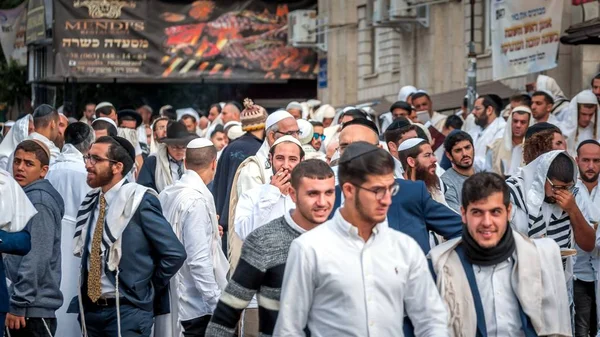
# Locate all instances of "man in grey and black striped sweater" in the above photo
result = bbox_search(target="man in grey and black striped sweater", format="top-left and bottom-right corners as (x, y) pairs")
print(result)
(206, 159), (335, 337)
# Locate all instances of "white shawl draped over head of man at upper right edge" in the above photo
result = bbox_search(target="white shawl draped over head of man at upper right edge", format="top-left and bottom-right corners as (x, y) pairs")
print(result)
(560, 90), (600, 156)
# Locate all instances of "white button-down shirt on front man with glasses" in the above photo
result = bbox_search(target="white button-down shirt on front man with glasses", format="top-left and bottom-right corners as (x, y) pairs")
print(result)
(273, 210), (448, 337)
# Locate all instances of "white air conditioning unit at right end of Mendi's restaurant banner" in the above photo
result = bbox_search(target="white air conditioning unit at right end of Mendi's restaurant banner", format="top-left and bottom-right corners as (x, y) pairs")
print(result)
(288, 10), (317, 47)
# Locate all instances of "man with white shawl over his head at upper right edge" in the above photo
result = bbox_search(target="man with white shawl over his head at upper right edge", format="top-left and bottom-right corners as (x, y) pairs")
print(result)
(561, 90), (600, 156)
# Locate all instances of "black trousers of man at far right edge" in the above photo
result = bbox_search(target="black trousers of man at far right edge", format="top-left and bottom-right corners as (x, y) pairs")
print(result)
(573, 280), (598, 337)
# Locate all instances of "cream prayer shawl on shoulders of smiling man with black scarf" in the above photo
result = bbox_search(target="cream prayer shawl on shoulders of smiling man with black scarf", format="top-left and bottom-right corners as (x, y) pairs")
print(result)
(429, 231), (571, 337)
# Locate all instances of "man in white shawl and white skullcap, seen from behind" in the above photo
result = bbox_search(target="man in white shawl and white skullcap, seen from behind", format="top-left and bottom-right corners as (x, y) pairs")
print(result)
(154, 138), (229, 337)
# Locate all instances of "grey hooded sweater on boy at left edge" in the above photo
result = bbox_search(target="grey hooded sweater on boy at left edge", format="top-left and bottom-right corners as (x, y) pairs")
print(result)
(4, 179), (65, 318)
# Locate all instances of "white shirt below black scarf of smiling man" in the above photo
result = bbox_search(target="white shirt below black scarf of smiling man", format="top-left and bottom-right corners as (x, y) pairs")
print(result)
(473, 258), (524, 337)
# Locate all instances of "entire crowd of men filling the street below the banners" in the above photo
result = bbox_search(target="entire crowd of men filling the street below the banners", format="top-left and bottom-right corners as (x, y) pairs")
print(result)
(0, 74), (600, 337)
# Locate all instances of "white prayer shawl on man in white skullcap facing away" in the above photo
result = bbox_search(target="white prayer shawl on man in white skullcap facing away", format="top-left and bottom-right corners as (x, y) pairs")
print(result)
(154, 171), (229, 337)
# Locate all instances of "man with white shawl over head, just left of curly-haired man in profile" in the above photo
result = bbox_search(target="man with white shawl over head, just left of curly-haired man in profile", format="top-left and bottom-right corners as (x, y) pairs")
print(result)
(485, 106), (533, 177)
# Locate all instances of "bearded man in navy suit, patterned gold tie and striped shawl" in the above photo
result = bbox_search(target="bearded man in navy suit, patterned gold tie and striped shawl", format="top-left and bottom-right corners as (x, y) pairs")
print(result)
(70, 137), (186, 337)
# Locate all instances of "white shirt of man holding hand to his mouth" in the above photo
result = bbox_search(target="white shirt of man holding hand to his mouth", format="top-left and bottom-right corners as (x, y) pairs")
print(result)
(235, 184), (296, 241)
